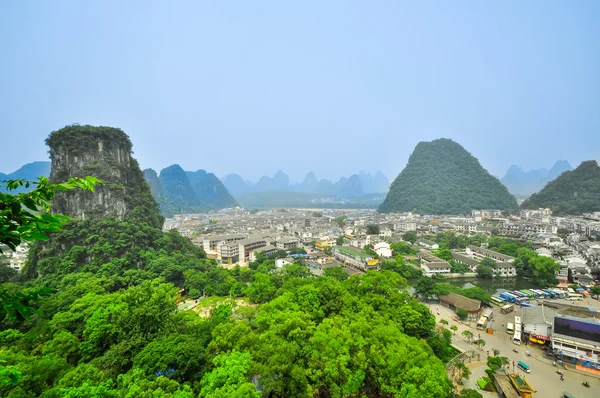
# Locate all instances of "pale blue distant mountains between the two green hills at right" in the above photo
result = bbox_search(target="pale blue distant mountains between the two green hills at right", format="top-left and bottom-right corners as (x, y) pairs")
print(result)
(500, 160), (573, 196)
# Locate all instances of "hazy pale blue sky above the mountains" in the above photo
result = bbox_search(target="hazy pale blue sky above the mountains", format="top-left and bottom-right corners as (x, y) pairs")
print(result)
(0, 0), (600, 181)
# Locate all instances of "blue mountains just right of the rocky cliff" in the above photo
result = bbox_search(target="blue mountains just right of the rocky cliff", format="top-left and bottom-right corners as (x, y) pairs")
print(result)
(144, 164), (238, 215)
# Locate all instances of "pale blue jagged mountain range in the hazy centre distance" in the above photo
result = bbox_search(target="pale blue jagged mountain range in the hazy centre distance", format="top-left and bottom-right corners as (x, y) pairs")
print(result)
(221, 170), (390, 197)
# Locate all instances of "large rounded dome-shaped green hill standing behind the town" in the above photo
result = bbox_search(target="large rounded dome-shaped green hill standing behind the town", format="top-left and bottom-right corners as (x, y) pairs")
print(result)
(379, 138), (517, 214)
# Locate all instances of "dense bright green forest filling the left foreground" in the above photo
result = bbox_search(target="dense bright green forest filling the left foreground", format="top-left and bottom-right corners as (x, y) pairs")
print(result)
(0, 178), (452, 398)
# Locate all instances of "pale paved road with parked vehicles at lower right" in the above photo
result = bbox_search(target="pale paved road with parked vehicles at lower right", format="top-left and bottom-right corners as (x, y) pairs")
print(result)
(429, 299), (600, 398)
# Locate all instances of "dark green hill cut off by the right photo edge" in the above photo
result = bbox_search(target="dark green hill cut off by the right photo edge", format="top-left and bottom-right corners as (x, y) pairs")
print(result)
(521, 160), (600, 214)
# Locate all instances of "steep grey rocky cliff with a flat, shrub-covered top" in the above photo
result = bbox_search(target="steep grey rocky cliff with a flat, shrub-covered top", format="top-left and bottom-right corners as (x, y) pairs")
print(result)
(46, 125), (162, 224)
